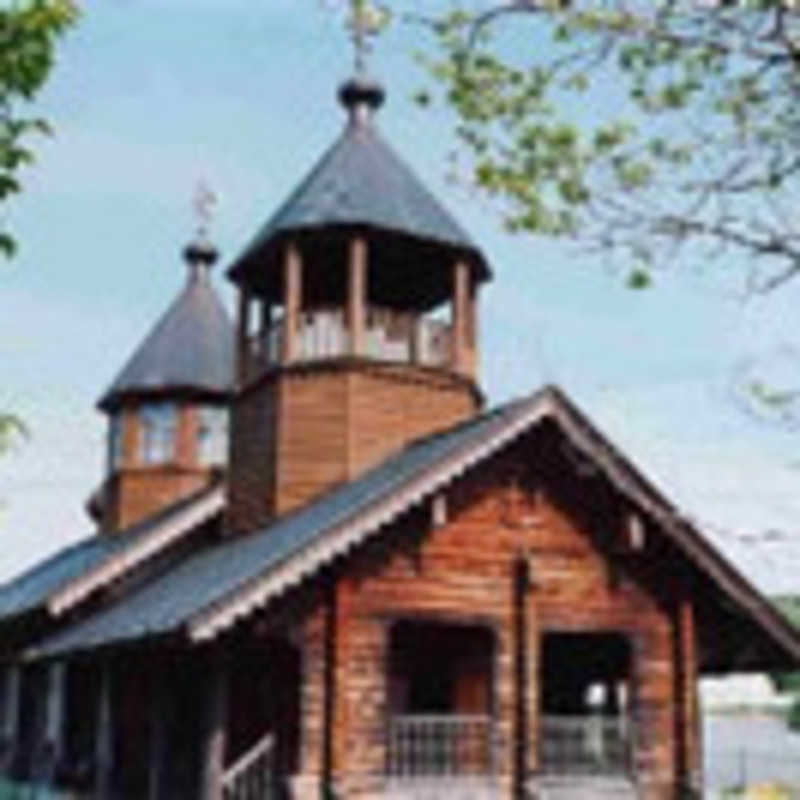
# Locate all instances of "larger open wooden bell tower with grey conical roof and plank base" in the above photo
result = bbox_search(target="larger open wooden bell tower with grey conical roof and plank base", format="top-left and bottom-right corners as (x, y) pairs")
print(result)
(222, 77), (490, 532)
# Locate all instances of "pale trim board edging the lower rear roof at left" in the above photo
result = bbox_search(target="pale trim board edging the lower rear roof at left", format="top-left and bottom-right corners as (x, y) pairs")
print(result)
(47, 486), (225, 617)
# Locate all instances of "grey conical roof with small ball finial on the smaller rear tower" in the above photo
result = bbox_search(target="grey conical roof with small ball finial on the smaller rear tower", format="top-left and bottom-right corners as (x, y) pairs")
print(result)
(98, 246), (235, 410)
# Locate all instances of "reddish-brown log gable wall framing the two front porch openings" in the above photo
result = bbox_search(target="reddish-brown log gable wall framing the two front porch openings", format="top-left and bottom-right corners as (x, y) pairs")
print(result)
(290, 432), (698, 800)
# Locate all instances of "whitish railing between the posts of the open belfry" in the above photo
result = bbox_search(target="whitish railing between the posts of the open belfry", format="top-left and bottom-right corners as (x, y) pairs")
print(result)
(247, 306), (451, 376)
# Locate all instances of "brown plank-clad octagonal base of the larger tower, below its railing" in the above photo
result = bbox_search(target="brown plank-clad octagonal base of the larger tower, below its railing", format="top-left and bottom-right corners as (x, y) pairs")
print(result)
(228, 360), (478, 531)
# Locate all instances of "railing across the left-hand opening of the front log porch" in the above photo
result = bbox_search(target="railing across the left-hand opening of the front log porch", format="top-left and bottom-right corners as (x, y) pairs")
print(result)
(387, 714), (495, 778)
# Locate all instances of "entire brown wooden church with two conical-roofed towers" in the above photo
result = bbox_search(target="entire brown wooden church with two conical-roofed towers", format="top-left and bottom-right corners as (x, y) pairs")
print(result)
(0, 69), (800, 800)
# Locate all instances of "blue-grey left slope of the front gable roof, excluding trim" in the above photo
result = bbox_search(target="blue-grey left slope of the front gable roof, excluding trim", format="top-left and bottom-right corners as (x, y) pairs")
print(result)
(29, 404), (516, 656)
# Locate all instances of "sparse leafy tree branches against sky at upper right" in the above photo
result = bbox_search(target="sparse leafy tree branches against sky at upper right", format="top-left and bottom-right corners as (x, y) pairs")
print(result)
(418, 0), (800, 291)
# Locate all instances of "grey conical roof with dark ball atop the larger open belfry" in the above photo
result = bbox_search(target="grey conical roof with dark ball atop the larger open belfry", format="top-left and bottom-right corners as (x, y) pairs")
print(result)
(232, 79), (488, 288)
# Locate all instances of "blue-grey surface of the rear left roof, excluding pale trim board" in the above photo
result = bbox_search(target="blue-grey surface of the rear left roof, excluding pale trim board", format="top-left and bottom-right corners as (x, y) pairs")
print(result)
(0, 489), (225, 620)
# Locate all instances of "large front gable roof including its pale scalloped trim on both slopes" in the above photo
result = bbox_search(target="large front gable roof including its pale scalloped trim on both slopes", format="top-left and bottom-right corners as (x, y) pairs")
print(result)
(29, 387), (800, 661)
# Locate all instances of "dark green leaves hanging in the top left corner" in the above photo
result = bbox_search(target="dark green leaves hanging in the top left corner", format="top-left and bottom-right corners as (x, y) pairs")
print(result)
(0, 0), (77, 256)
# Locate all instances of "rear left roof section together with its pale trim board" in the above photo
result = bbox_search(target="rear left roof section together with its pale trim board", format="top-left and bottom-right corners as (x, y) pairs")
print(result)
(0, 486), (225, 621)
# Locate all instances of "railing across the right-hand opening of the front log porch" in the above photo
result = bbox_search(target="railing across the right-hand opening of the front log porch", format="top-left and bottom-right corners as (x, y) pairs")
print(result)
(539, 714), (634, 775)
